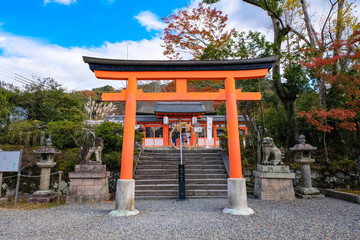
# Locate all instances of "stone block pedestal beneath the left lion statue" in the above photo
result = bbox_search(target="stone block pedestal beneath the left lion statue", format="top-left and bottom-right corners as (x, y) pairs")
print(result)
(66, 164), (110, 203)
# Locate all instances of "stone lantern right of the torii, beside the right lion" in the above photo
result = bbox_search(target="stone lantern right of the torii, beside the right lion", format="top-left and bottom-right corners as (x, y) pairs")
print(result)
(290, 135), (322, 198)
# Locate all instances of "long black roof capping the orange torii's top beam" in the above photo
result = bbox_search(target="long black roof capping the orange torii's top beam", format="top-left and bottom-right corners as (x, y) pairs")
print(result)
(83, 56), (277, 72)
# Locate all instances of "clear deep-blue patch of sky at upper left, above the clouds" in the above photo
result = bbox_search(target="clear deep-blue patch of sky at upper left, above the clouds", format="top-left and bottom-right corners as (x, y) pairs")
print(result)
(0, 0), (189, 47)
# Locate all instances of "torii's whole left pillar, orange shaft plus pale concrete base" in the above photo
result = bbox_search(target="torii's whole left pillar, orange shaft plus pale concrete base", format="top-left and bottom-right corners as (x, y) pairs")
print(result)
(109, 77), (139, 217)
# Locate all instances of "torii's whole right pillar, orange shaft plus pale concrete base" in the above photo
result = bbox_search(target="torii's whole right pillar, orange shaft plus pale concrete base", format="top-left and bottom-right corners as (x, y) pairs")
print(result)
(223, 77), (254, 215)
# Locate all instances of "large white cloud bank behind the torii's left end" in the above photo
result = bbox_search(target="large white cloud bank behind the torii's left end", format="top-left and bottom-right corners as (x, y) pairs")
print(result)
(0, 31), (165, 90)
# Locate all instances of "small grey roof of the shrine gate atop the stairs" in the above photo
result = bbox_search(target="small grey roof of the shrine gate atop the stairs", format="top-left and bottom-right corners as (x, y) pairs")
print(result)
(154, 102), (205, 113)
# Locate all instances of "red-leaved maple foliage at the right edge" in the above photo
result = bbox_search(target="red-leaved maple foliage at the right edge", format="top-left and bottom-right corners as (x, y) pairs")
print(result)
(300, 24), (360, 135)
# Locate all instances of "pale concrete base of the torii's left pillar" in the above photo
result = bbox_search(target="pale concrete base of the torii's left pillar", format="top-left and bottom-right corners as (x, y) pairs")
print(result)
(109, 179), (139, 217)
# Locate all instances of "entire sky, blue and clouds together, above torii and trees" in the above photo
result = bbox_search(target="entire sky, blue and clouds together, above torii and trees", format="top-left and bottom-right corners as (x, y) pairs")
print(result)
(0, 0), (354, 91)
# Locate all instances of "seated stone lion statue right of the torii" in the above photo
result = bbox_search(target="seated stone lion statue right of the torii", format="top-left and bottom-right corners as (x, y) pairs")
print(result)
(261, 137), (283, 165)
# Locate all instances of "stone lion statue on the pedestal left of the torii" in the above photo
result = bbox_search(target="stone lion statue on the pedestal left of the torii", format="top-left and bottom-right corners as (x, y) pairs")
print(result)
(81, 137), (104, 164)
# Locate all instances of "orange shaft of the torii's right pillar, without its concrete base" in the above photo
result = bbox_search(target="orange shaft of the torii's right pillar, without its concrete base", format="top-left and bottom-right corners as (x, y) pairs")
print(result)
(225, 77), (242, 178)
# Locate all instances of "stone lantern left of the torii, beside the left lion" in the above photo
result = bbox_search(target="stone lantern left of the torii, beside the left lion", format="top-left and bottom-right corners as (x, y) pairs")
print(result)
(28, 138), (60, 203)
